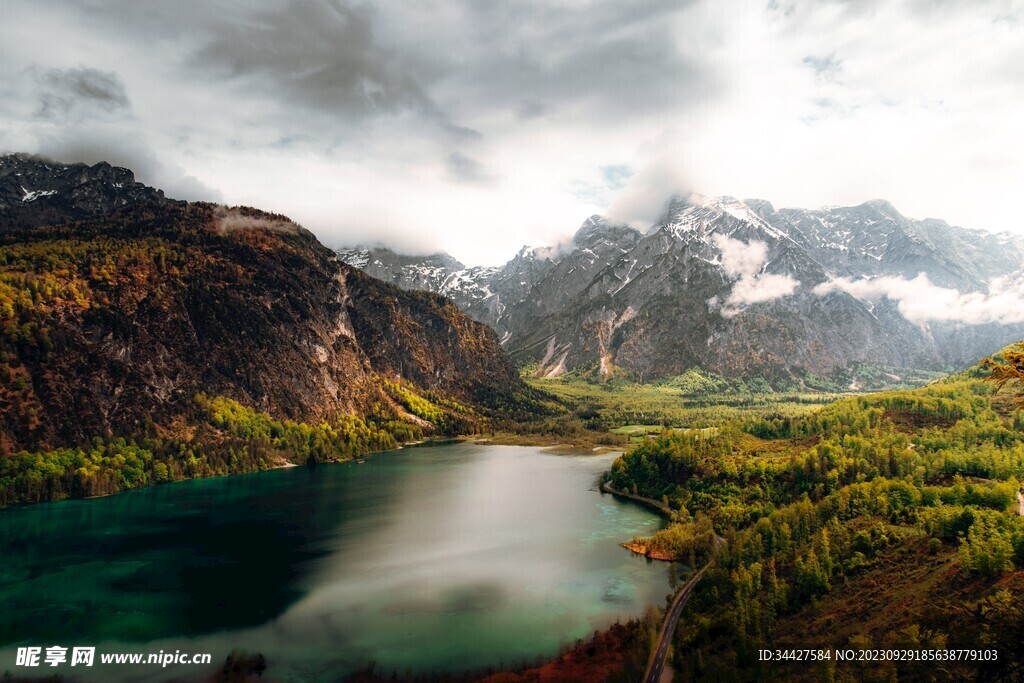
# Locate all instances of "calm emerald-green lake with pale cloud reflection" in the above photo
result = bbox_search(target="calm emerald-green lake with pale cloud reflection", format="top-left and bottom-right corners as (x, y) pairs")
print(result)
(0, 443), (671, 681)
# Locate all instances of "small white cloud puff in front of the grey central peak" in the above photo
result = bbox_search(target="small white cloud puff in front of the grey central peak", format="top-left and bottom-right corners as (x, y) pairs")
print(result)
(713, 234), (800, 317)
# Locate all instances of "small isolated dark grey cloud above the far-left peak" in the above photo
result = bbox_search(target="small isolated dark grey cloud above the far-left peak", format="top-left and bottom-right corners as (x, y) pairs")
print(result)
(33, 69), (131, 121)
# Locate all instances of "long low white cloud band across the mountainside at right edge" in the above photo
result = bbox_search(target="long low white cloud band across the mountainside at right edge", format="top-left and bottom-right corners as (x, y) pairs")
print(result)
(814, 273), (1024, 325)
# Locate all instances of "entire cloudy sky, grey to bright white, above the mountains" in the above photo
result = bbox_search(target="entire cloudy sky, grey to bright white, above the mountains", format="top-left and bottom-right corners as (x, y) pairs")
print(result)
(0, 0), (1024, 264)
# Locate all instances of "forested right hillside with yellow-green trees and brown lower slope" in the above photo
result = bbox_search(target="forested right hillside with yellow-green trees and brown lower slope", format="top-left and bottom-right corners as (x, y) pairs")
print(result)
(609, 350), (1024, 680)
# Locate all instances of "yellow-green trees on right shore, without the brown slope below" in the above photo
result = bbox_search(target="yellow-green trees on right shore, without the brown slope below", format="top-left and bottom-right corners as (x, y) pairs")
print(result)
(610, 370), (1024, 678)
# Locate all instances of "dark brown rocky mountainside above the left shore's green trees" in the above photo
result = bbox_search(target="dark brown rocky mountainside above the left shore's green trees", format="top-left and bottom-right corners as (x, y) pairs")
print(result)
(0, 174), (522, 454)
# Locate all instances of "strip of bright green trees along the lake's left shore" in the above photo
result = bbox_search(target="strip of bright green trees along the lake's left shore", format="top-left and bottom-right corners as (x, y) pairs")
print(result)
(0, 394), (440, 506)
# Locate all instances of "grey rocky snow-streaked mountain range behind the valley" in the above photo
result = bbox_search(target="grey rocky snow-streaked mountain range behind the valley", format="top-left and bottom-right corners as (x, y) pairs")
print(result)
(339, 195), (1024, 380)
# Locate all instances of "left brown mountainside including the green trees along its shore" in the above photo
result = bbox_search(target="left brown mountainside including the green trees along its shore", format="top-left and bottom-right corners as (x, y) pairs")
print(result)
(0, 194), (531, 505)
